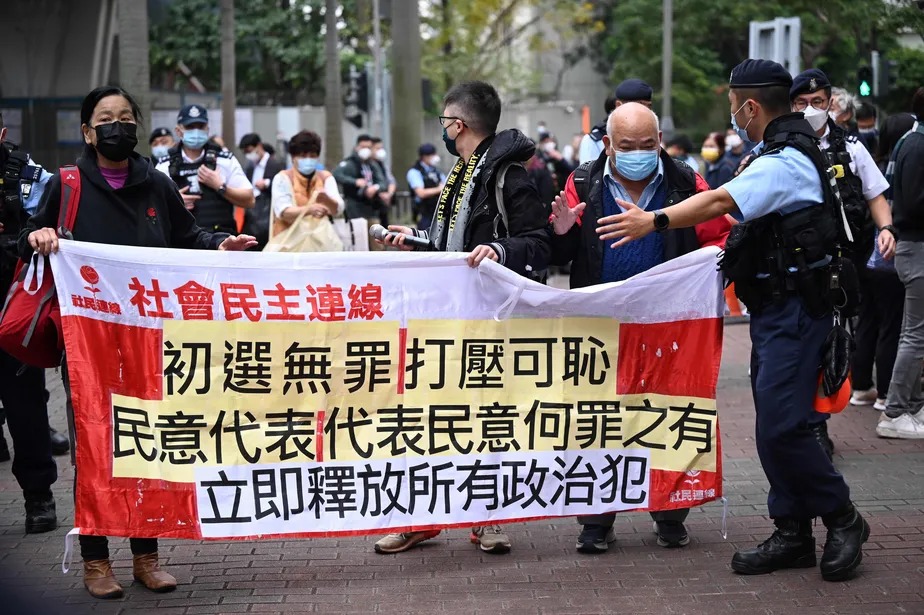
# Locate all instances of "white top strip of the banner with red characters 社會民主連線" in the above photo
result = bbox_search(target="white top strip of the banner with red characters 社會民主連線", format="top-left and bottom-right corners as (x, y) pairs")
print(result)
(51, 240), (725, 328)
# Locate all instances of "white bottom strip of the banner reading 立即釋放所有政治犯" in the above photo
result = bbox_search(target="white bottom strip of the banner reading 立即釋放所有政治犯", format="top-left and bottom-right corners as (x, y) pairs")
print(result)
(195, 449), (650, 538)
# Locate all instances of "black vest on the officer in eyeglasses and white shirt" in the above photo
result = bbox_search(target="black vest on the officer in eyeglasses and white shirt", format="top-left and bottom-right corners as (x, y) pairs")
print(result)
(825, 121), (876, 268)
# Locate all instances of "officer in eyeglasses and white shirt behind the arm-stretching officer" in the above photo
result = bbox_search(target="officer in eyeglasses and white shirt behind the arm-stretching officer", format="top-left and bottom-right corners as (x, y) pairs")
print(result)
(789, 68), (896, 457)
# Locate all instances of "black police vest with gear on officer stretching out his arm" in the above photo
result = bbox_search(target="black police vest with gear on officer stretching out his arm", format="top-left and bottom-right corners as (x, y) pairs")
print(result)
(720, 113), (859, 318)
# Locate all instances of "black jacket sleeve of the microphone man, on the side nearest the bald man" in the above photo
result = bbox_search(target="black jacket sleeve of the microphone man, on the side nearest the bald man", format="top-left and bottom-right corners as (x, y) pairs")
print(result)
(491, 165), (552, 275)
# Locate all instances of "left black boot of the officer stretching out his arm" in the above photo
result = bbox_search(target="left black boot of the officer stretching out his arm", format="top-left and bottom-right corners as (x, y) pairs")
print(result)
(732, 519), (815, 574)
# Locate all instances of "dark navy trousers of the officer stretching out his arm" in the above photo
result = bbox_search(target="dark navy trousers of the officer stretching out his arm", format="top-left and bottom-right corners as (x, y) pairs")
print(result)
(751, 297), (850, 519)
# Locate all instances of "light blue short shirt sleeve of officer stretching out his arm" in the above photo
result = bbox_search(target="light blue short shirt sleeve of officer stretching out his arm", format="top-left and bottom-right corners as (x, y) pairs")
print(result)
(720, 142), (824, 222)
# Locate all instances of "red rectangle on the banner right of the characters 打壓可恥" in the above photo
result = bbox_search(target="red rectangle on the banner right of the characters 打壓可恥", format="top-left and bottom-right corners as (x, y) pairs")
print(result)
(616, 318), (722, 399)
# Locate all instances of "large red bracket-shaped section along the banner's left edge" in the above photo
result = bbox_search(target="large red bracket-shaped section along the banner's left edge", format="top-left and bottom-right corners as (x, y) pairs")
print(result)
(64, 316), (200, 538)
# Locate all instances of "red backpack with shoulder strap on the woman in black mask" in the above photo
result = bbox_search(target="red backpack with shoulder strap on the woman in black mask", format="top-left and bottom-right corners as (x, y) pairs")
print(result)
(0, 166), (80, 367)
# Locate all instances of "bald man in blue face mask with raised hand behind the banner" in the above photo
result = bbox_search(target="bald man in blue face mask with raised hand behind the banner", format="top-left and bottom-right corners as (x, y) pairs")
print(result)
(551, 103), (731, 554)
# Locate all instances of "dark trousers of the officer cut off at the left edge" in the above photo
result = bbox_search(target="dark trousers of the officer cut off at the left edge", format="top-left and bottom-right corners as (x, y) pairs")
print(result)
(0, 351), (58, 494)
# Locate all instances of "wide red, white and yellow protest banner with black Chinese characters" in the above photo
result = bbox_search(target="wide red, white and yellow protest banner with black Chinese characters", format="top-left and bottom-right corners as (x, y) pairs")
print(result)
(52, 241), (724, 539)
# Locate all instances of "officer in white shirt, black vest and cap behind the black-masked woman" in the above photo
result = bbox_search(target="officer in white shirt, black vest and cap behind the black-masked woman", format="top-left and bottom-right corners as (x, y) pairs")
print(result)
(157, 105), (254, 233)
